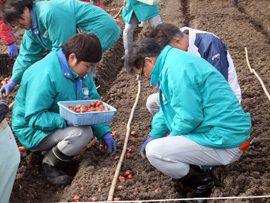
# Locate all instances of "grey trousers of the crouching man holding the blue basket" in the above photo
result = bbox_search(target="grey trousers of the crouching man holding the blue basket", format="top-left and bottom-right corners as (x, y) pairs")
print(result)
(30, 126), (94, 156)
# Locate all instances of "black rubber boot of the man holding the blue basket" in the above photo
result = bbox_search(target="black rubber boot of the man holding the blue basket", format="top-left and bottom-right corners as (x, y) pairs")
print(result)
(42, 146), (73, 186)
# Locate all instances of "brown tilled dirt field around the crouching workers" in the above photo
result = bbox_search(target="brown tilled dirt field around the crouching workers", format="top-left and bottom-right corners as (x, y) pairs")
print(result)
(3, 0), (270, 203)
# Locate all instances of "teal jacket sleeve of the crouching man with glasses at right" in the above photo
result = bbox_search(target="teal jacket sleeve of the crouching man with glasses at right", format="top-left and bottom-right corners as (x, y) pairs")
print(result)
(168, 67), (203, 136)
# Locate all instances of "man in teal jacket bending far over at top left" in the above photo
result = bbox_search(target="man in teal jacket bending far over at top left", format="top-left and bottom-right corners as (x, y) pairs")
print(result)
(1, 0), (121, 96)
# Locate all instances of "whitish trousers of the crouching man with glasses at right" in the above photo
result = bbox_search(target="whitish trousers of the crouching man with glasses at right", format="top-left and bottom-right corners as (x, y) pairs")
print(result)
(146, 136), (243, 179)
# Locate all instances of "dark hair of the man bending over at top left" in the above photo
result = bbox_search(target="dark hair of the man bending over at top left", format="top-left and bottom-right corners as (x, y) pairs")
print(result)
(1, 0), (34, 25)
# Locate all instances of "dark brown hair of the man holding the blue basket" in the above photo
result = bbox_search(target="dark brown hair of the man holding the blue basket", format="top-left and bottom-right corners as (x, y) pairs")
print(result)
(61, 33), (102, 63)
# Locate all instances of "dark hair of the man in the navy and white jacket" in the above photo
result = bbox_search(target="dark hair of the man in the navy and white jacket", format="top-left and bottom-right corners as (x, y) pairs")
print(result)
(147, 23), (184, 48)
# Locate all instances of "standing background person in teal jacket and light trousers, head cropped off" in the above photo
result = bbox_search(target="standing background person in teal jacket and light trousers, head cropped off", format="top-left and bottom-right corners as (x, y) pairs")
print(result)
(121, 0), (162, 60)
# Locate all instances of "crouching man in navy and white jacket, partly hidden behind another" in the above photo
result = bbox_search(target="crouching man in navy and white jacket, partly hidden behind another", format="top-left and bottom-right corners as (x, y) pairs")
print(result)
(146, 23), (241, 114)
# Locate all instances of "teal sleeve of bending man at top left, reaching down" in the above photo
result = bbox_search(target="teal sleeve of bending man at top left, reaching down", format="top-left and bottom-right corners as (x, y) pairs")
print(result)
(11, 31), (45, 83)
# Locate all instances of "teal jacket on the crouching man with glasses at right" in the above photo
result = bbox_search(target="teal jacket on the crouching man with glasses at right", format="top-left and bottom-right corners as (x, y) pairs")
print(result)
(149, 46), (251, 149)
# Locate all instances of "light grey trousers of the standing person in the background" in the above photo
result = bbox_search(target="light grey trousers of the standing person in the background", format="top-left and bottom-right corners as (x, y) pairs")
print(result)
(123, 12), (162, 55)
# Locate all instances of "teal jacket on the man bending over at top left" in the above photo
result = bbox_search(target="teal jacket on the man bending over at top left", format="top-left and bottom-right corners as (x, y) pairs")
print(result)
(12, 0), (121, 83)
